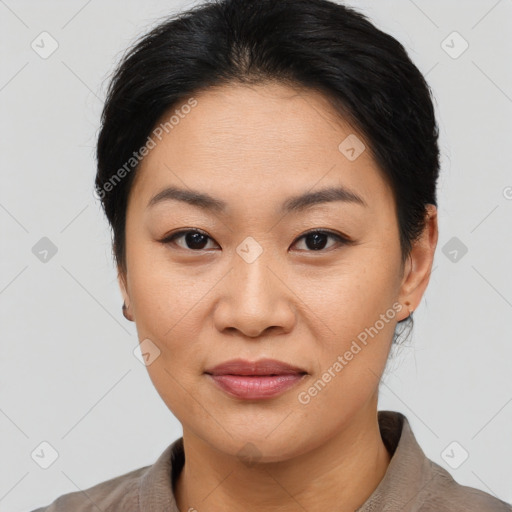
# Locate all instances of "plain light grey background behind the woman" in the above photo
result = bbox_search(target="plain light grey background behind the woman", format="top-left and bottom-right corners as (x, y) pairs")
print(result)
(0, 0), (512, 512)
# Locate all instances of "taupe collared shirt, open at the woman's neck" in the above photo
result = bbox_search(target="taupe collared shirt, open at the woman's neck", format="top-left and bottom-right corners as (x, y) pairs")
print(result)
(33, 411), (512, 512)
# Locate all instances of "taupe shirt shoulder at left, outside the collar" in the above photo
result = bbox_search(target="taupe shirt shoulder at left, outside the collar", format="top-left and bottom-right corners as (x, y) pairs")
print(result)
(29, 466), (150, 512)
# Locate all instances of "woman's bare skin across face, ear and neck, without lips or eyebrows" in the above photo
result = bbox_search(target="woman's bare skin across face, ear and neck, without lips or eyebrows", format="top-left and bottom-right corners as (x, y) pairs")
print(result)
(119, 83), (438, 512)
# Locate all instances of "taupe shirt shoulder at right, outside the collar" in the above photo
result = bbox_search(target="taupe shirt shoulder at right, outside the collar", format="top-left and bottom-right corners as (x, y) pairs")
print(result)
(419, 459), (512, 512)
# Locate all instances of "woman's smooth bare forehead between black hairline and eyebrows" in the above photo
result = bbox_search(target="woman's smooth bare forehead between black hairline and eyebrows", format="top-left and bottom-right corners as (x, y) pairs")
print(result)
(128, 83), (390, 215)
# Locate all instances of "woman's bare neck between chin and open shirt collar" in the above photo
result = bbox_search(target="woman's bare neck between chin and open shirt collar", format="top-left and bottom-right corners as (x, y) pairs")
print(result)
(174, 404), (390, 512)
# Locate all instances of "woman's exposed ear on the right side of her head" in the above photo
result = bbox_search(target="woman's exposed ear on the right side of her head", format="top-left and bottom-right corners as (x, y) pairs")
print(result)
(398, 204), (439, 320)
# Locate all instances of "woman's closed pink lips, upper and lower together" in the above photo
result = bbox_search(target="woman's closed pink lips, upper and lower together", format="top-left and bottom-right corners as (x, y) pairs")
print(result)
(205, 359), (307, 400)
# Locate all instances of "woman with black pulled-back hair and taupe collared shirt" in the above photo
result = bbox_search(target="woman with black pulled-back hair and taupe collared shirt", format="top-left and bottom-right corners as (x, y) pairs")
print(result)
(34, 0), (512, 512)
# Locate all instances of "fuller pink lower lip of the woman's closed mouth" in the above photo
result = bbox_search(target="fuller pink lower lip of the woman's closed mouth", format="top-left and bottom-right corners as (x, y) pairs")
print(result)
(208, 373), (306, 400)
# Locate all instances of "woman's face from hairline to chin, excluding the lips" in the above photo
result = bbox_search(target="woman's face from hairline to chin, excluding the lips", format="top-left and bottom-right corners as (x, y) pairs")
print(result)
(120, 84), (436, 461)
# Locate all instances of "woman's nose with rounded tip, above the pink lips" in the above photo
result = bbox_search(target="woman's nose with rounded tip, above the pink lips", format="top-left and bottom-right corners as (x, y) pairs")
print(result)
(214, 249), (296, 338)
